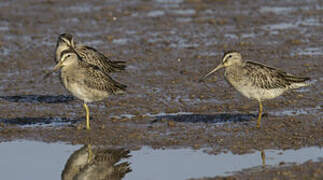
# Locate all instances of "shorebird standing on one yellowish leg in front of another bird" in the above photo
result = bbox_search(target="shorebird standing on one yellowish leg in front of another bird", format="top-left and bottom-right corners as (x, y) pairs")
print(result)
(54, 48), (126, 130)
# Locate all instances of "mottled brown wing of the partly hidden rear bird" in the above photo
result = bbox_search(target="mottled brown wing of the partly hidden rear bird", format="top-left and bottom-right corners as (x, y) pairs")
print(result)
(76, 46), (126, 72)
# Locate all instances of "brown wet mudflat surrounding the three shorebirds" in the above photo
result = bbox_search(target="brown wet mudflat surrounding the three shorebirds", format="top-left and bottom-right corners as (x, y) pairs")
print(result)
(0, 0), (323, 179)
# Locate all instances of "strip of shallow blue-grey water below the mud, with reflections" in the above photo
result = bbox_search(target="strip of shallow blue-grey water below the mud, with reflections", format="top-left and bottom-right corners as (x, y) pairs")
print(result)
(0, 140), (323, 180)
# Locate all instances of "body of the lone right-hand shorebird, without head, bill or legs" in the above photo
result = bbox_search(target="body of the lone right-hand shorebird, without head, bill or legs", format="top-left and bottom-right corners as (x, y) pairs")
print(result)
(225, 61), (309, 100)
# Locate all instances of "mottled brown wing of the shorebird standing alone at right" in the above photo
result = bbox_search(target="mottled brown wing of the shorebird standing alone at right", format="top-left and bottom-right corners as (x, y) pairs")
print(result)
(244, 61), (292, 89)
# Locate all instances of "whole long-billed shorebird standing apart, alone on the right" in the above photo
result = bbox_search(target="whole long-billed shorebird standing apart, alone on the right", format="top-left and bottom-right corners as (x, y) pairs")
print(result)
(200, 51), (310, 128)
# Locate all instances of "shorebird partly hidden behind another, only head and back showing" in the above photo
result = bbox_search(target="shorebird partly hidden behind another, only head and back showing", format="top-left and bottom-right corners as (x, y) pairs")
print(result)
(55, 33), (126, 73)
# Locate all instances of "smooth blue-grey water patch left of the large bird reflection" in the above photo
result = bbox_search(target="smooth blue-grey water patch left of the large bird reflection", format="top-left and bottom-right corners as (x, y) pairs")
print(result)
(0, 141), (81, 180)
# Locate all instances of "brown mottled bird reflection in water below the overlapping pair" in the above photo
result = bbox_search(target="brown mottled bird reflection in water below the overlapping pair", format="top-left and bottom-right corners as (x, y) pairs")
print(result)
(62, 144), (131, 180)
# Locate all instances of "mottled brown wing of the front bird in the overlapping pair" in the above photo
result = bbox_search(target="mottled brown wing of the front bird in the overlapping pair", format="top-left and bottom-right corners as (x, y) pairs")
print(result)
(80, 62), (127, 94)
